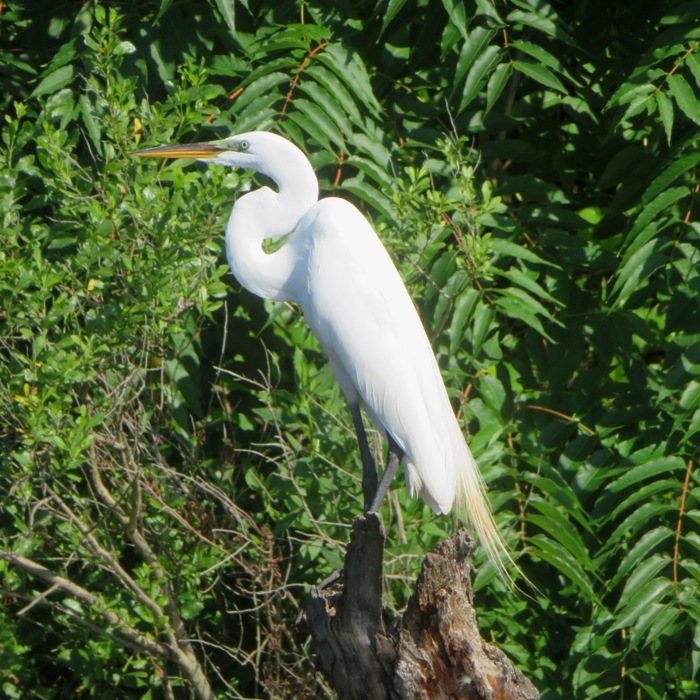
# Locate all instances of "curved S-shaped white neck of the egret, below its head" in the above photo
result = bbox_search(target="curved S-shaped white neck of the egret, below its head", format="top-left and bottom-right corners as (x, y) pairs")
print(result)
(226, 165), (318, 301)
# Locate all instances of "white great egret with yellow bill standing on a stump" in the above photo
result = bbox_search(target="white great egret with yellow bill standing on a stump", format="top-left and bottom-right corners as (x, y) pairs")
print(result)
(135, 131), (510, 578)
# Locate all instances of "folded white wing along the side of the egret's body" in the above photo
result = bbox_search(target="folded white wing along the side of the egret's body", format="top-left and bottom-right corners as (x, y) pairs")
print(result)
(295, 198), (462, 513)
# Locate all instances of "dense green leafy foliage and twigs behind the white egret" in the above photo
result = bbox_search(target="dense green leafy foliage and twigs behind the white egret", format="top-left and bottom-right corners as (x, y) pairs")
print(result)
(0, 0), (700, 698)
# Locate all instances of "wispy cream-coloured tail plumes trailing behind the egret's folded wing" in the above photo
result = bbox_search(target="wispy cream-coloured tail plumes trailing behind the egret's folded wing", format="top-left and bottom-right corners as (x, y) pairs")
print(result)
(454, 438), (524, 586)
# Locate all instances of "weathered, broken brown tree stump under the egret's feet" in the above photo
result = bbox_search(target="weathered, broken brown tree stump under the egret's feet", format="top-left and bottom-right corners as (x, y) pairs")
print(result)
(304, 513), (539, 700)
